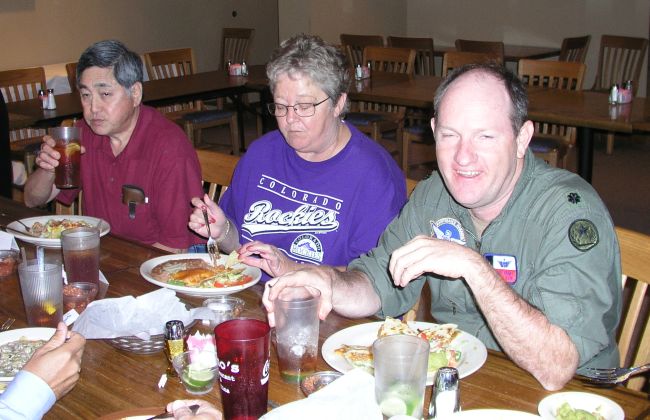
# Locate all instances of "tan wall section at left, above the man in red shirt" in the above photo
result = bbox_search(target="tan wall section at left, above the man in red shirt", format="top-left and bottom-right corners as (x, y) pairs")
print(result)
(0, 0), (278, 71)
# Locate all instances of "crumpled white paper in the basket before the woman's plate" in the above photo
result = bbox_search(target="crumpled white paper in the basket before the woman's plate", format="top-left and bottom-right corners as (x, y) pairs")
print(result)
(72, 289), (215, 340)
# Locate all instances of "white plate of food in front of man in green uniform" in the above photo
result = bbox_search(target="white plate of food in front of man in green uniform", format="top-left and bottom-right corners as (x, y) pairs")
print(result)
(321, 317), (487, 385)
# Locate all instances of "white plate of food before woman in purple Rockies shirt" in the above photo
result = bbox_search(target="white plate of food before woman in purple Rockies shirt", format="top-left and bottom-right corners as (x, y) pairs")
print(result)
(140, 252), (262, 297)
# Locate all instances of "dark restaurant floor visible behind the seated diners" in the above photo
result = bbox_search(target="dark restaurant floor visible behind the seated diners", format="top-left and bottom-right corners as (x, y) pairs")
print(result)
(199, 118), (650, 235)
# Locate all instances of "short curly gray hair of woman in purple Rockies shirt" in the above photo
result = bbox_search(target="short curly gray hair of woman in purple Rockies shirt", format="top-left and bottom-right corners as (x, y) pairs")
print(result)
(266, 34), (350, 112)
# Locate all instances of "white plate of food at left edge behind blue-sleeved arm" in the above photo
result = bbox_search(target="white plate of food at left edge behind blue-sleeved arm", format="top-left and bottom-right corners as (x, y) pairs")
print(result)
(0, 328), (56, 392)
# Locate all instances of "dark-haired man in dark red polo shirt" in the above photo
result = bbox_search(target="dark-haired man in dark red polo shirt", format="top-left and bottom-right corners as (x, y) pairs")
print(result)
(25, 40), (203, 251)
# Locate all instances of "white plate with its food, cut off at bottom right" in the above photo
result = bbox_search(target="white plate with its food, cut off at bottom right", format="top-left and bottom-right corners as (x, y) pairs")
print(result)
(537, 392), (625, 420)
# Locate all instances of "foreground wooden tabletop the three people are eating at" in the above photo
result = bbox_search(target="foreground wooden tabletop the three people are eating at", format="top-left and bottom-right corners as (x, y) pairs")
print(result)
(0, 197), (650, 419)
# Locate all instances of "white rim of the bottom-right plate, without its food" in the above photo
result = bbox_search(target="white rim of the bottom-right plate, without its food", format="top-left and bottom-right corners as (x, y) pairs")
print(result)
(537, 392), (625, 420)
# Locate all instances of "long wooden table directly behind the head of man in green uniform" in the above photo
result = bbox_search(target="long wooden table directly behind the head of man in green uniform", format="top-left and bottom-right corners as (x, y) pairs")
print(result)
(349, 72), (650, 182)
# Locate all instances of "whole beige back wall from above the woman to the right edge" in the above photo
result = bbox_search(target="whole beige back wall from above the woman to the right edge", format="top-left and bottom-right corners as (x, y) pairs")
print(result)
(278, 0), (650, 96)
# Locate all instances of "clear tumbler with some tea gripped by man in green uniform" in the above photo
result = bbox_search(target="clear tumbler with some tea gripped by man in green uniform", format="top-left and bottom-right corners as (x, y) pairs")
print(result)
(274, 287), (320, 383)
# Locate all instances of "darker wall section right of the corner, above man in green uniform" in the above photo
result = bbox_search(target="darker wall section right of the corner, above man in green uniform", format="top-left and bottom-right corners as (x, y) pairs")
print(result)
(405, 0), (650, 96)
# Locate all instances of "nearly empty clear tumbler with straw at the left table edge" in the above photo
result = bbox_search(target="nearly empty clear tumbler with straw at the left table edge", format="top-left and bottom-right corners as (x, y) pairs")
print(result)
(18, 260), (63, 327)
